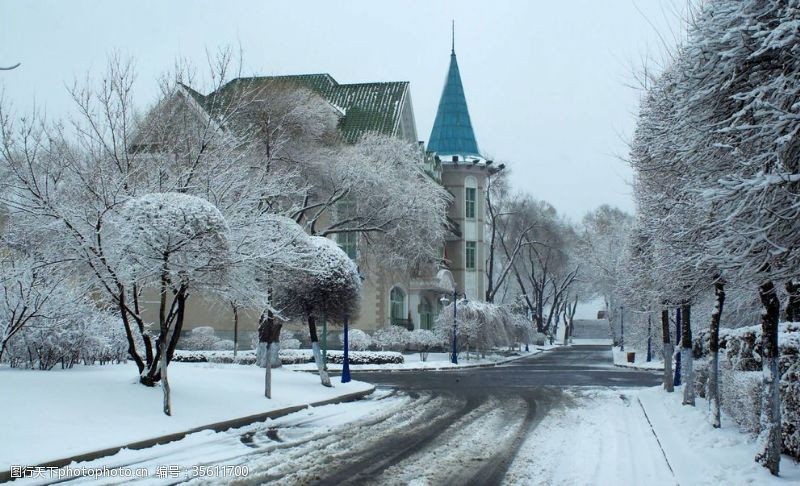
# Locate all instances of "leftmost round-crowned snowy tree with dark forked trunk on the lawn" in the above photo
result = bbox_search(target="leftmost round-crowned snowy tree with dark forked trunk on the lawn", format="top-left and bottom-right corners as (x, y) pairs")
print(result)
(104, 193), (230, 415)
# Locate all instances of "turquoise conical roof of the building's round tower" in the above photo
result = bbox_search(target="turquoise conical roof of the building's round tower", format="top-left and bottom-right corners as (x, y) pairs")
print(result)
(428, 50), (480, 157)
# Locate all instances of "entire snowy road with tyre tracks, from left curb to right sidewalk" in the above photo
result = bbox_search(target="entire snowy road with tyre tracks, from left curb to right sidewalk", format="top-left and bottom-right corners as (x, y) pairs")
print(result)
(12, 349), (675, 485)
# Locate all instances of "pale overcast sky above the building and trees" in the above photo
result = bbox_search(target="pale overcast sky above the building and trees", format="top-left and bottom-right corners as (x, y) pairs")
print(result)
(0, 0), (686, 221)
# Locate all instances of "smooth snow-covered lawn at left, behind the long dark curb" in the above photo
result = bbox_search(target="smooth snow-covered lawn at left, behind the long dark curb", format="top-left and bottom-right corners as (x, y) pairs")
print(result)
(0, 363), (371, 471)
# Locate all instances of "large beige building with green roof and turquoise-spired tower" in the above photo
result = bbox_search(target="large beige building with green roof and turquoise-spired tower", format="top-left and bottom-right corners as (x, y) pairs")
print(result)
(138, 43), (497, 344)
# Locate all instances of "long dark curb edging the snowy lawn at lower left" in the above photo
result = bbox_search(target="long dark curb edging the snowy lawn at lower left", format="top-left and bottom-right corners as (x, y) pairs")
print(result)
(0, 386), (375, 483)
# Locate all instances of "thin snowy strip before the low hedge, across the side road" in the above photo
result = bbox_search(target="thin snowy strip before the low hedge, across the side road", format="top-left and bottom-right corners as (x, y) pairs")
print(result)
(284, 345), (558, 371)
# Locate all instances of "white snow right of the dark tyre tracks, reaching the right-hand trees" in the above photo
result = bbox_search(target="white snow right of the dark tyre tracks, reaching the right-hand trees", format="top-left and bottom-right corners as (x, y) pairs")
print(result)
(505, 388), (800, 485)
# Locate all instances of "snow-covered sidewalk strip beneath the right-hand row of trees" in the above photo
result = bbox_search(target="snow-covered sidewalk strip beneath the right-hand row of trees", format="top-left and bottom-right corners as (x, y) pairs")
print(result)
(636, 387), (800, 485)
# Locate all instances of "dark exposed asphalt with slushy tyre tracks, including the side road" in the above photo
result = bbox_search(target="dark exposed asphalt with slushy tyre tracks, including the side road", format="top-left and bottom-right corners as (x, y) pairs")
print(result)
(252, 346), (659, 485)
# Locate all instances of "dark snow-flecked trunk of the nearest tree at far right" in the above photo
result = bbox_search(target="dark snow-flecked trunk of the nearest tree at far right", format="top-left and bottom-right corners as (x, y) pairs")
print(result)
(756, 280), (782, 476)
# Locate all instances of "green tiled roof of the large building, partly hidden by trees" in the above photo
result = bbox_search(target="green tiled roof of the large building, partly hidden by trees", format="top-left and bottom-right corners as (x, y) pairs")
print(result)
(189, 74), (408, 142)
